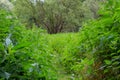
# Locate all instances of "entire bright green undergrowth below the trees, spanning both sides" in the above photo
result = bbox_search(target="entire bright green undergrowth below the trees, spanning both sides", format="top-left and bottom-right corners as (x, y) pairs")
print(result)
(0, 0), (120, 80)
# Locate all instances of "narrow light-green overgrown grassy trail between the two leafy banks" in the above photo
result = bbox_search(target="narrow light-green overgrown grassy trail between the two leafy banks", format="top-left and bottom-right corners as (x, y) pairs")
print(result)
(48, 33), (78, 80)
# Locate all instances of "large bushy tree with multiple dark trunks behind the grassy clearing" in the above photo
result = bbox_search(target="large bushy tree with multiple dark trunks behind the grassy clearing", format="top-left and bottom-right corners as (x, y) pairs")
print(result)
(14, 0), (84, 34)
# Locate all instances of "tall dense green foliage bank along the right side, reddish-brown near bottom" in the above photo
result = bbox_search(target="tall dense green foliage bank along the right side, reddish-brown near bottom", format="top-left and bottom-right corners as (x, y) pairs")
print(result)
(71, 0), (120, 80)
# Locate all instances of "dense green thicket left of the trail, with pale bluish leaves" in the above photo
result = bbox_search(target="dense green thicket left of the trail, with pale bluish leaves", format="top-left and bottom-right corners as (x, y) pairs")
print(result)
(0, 10), (56, 80)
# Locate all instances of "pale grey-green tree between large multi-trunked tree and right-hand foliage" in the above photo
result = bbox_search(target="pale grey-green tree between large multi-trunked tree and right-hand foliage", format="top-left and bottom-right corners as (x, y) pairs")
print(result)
(82, 0), (105, 21)
